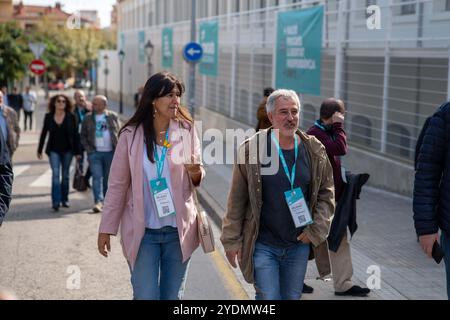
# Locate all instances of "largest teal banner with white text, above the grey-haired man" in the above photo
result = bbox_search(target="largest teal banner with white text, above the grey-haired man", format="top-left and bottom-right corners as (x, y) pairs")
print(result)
(275, 6), (324, 96)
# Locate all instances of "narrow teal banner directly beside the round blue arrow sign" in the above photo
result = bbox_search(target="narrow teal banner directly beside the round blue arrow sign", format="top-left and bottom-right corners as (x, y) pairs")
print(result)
(200, 21), (219, 77)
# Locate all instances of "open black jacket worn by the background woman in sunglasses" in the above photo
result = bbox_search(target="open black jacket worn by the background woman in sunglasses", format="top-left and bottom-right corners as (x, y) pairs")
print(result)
(38, 113), (81, 155)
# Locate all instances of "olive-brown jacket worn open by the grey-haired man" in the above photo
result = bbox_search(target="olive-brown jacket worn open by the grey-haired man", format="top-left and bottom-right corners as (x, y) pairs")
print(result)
(220, 128), (335, 283)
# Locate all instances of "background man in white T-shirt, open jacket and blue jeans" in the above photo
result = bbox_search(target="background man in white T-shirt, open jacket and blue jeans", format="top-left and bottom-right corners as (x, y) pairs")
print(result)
(81, 96), (121, 213)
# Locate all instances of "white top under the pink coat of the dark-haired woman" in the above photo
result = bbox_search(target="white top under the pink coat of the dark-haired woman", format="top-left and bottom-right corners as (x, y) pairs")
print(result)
(142, 144), (177, 229)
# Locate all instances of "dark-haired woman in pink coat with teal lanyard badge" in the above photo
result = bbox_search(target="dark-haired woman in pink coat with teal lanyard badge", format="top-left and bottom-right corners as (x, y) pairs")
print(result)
(98, 72), (205, 300)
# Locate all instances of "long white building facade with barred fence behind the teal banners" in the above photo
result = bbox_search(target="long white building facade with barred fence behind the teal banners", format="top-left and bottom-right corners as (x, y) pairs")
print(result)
(98, 0), (450, 195)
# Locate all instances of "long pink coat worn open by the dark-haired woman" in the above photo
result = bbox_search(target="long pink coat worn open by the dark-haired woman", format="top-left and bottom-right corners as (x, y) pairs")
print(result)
(99, 120), (205, 268)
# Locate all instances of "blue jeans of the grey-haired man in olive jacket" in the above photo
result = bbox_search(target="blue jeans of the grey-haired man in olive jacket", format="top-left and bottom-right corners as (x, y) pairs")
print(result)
(253, 241), (309, 300)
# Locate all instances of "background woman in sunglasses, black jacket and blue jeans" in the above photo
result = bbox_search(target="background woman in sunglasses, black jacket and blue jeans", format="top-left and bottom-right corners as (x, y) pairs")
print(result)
(37, 94), (81, 212)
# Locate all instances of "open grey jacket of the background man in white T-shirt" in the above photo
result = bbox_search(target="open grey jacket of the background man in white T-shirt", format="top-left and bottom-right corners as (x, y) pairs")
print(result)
(80, 110), (121, 153)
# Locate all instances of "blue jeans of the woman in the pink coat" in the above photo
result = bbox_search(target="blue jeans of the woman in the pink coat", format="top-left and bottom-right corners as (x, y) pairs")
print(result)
(131, 227), (190, 300)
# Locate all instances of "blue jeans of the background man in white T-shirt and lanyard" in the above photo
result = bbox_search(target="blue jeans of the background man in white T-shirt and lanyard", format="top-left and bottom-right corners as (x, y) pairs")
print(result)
(88, 151), (114, 203)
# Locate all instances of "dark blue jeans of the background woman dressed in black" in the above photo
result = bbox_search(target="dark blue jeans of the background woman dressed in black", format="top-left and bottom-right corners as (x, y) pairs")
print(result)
(49, 151), (73, 207)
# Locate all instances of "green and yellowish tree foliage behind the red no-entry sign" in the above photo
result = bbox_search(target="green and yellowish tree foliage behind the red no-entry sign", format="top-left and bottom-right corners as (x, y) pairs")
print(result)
(0, 19), (115, 84)
